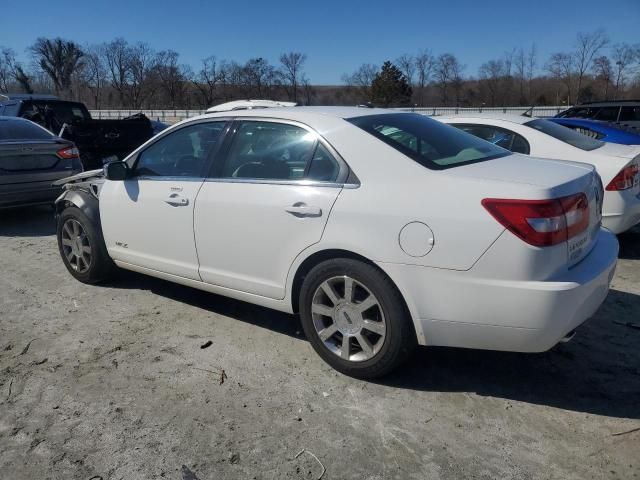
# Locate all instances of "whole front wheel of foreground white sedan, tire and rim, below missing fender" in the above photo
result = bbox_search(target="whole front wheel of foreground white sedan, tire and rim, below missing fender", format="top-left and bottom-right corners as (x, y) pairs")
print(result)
(57, 207), (115, 284)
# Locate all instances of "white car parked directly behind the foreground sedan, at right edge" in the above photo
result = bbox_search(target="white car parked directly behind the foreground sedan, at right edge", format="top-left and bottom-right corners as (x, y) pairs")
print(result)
(434, 114), (640, 234)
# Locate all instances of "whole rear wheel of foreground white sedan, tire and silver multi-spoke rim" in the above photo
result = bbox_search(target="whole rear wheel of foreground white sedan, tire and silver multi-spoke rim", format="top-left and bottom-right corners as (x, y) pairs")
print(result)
(300, 259), (416, 378)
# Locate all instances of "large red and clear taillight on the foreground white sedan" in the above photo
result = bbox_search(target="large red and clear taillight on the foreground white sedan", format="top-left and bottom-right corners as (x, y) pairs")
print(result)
(482, 193), (589, 247)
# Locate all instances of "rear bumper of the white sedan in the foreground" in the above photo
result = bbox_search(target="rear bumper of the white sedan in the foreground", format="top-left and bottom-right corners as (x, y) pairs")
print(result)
(381, 229), (618, 352)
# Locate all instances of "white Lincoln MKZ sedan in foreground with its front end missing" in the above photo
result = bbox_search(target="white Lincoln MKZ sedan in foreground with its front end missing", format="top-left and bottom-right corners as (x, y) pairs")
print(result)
(57, 107), (618, 378)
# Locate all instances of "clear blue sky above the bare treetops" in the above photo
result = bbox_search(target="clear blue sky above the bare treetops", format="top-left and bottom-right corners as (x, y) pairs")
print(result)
(0, 0), (640, 84)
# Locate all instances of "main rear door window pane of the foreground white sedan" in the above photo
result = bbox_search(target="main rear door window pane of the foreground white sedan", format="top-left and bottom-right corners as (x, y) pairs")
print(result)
(220, 121), (322, 180)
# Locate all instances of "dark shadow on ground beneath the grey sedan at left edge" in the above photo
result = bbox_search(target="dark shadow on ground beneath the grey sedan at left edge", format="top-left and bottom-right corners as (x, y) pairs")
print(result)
(0, 205), (56, 237)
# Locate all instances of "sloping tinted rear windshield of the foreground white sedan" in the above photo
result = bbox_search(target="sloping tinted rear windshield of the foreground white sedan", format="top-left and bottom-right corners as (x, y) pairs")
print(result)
(347, 113), (511, 170)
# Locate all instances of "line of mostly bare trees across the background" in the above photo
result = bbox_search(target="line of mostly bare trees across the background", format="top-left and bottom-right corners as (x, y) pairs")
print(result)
(0, 30), (640, 109)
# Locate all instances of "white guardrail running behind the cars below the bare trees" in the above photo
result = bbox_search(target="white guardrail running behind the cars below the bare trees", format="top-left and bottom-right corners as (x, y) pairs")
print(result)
(90, 106), (568, 123)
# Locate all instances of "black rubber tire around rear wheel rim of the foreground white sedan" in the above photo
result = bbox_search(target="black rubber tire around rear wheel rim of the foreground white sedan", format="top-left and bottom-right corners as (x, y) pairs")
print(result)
(299, 258), (417, 379)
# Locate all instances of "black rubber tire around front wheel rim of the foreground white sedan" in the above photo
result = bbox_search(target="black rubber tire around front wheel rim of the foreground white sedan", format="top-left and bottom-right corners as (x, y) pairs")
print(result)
(56, 207), (116, 284)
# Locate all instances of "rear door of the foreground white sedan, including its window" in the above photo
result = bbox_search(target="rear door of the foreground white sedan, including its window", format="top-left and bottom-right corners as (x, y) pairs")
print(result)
(194, 120), (348, 299)
